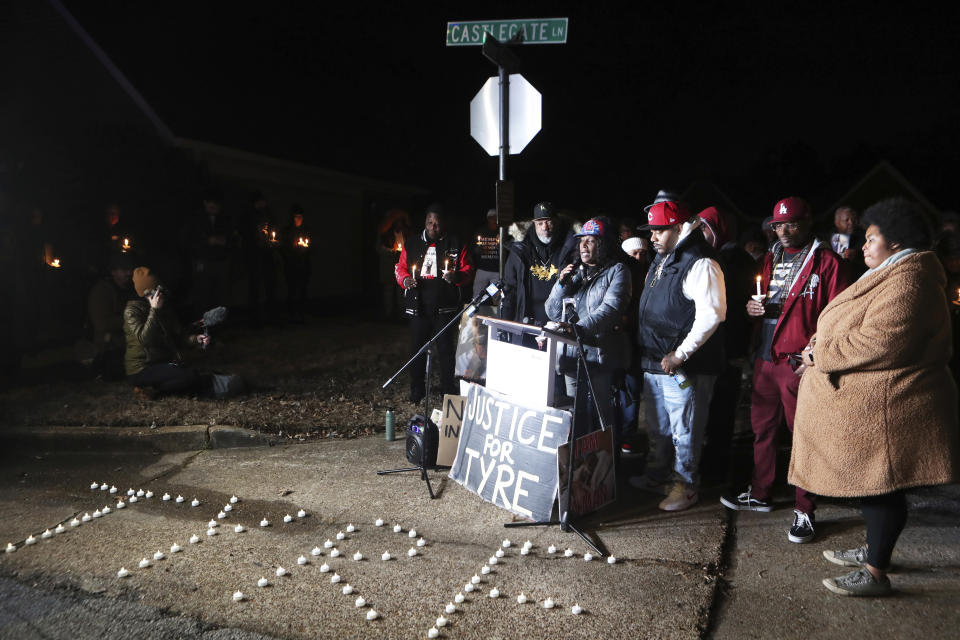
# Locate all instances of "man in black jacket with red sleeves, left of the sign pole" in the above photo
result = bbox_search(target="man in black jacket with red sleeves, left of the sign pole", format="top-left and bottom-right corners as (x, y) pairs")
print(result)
(395, 204), (474, 404)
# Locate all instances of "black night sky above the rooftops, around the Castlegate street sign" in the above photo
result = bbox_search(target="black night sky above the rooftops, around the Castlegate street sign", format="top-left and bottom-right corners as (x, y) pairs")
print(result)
(64, 0), (960, 218)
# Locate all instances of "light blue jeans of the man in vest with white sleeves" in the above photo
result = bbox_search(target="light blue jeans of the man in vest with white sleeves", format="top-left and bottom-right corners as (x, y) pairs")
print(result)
(643, 372), (717, 487)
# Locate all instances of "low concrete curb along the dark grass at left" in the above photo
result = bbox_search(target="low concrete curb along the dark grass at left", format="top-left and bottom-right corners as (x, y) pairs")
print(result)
(0, 425), (278, 453)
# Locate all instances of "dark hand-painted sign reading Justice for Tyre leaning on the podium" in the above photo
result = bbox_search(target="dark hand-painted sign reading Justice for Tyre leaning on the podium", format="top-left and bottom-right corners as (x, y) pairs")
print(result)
(450, 384), (570, 520)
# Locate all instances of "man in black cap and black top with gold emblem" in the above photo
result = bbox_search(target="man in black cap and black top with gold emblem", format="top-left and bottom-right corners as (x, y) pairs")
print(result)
(501, 202), (576, 326)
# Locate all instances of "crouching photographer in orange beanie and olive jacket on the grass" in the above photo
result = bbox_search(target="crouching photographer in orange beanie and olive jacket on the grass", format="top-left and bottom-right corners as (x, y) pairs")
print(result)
(123, 267), (210, 398)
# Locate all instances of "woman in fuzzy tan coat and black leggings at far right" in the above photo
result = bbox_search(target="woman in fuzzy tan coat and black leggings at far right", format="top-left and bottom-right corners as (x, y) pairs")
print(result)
(789, 200), (960, 596)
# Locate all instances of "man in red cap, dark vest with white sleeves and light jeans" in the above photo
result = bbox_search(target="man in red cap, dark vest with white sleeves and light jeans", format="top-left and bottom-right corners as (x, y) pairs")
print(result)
(630, 200), (727, 511)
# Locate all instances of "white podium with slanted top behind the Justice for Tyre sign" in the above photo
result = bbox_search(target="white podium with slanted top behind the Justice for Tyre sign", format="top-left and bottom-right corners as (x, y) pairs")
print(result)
(479, 316), (576, 407)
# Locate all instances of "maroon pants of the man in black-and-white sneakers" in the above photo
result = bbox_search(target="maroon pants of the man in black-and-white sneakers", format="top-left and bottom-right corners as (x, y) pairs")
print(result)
(750, 358), (815, 514)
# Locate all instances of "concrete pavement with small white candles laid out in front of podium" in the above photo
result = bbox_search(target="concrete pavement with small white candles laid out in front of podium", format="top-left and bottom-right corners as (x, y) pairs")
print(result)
(0, 426), (960, 640)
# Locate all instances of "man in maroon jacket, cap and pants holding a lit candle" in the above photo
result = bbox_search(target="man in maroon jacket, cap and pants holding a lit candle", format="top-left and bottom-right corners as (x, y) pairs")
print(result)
(720, 197), (850, 543)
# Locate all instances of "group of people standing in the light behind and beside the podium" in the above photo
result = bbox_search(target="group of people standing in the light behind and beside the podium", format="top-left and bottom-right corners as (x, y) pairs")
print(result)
(395, 191), (960, 595)
